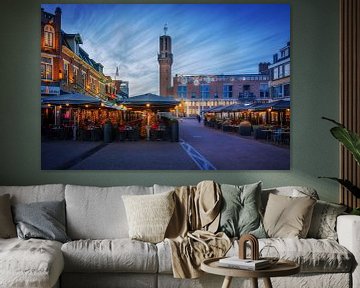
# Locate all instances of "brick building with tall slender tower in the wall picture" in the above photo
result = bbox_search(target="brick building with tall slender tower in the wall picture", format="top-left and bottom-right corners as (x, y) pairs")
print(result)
(158, 26), (276, 116)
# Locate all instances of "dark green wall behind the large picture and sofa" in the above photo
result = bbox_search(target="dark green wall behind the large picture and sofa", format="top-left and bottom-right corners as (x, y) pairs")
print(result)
(0, 0), (339, 201)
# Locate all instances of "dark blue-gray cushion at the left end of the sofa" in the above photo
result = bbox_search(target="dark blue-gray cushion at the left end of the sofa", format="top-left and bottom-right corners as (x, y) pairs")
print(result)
(13, 201), (70, 242)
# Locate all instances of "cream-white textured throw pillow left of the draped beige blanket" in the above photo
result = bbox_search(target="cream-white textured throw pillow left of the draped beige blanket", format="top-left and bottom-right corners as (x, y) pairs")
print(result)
(122, 191), (175, 243)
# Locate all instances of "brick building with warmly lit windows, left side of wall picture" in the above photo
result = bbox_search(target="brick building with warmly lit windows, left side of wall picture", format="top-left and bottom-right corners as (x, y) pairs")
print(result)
(41, 8), (128, 101)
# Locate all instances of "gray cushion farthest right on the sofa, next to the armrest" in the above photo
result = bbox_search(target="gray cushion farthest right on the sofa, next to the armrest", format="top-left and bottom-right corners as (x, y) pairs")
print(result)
(307, 200), (346, 240)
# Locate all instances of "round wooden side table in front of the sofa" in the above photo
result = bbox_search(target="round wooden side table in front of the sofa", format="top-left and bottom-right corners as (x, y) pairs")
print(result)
(201, 258), (300, 288)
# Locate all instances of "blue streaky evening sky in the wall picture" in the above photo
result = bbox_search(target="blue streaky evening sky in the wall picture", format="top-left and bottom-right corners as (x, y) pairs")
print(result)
(41, 4), (290, 96)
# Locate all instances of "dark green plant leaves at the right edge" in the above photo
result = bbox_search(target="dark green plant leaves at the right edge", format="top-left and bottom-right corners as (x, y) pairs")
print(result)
(319, 117), (360, 215)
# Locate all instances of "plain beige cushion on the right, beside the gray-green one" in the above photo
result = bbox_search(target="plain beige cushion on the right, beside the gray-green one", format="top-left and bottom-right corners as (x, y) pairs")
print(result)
(264, 194), (316, 238)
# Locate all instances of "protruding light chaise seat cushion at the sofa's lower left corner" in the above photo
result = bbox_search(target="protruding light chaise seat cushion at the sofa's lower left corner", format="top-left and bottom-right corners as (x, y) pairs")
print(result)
(0, 238), (64, 288)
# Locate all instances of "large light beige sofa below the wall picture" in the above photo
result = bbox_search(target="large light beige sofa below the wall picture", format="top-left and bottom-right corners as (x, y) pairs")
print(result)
(0, 185), (360, 288)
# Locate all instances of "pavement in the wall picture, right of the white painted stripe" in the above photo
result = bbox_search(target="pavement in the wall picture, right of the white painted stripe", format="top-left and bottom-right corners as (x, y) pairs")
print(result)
(180, 119), (290, 170)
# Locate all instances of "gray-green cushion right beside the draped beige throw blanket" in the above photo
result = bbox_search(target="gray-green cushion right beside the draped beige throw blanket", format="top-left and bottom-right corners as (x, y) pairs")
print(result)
(219, 182), (266, 238)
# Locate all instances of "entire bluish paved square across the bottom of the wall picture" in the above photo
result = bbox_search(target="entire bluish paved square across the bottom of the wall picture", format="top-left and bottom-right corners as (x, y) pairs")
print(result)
(41, 118), (290, 170)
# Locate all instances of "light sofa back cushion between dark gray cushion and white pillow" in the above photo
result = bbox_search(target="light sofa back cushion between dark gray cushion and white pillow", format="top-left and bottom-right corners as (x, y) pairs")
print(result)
(65, 185), (153, 239)
